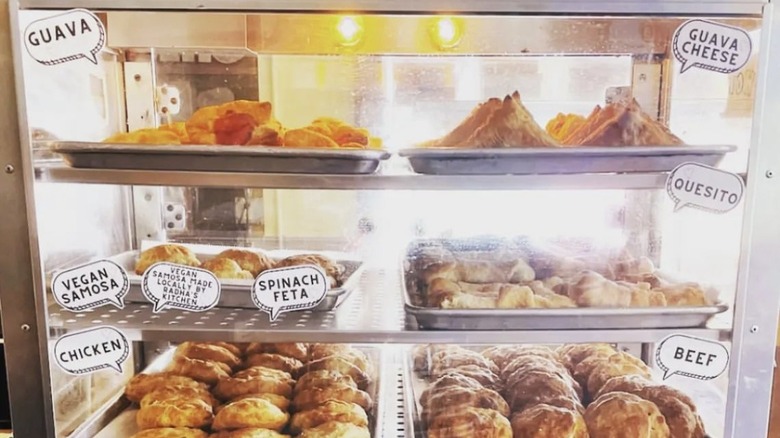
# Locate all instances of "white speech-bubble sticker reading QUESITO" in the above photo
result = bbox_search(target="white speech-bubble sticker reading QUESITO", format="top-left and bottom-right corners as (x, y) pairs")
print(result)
(666, 163), (745, 213)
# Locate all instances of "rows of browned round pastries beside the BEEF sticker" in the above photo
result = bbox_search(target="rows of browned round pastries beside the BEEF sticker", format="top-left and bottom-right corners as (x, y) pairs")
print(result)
(414, 344), (705, 438)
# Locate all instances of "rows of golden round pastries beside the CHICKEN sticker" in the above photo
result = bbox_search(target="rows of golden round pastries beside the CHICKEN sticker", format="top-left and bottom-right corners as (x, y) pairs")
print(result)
(125, 342), (372, 438)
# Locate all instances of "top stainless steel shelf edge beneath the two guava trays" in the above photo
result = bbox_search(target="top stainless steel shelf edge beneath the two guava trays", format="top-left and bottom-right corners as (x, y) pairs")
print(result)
(36, 164), (667, 190)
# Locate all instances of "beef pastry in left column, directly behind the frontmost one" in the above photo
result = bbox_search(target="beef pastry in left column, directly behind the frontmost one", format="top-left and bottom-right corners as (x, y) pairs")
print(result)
(423, 386), (510, 423)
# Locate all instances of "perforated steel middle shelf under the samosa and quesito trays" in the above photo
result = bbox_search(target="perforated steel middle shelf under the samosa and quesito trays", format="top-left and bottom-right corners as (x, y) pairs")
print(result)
(49, 271), (730, 344)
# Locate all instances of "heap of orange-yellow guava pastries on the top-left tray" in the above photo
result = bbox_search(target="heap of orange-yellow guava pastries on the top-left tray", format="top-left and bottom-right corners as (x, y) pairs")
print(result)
(104, 100), (381, 149)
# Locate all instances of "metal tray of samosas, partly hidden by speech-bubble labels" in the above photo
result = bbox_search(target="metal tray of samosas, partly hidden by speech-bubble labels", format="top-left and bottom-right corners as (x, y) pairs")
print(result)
(109, 245), (363, 312)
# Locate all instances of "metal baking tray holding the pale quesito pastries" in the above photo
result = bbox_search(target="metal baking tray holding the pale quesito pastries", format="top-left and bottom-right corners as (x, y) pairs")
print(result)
(402, 239), (728, 330)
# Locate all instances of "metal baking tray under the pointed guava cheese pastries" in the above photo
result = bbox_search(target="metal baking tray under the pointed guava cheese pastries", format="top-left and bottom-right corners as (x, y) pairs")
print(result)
(399, 146), (737, 175)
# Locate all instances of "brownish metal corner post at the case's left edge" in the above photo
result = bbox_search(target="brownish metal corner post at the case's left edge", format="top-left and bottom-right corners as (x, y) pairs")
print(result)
(0, 0), (54, 438)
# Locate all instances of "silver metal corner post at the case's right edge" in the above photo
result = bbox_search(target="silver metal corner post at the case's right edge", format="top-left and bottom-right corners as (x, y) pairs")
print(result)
(725, 4), (780, 438)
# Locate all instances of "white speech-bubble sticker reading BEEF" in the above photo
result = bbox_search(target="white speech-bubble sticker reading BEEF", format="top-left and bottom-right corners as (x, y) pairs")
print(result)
(655, 335), (729, 380)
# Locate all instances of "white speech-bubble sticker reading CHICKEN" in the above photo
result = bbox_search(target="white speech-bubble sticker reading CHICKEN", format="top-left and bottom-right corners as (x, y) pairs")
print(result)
(54, 326), (130, 375)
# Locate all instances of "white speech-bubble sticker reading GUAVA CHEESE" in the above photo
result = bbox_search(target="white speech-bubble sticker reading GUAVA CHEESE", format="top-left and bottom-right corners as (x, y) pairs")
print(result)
(672, 20), (753, 73)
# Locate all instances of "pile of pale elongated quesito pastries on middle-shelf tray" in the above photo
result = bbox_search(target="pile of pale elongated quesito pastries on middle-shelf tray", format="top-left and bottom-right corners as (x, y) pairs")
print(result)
(408, 241), (711, 309)
